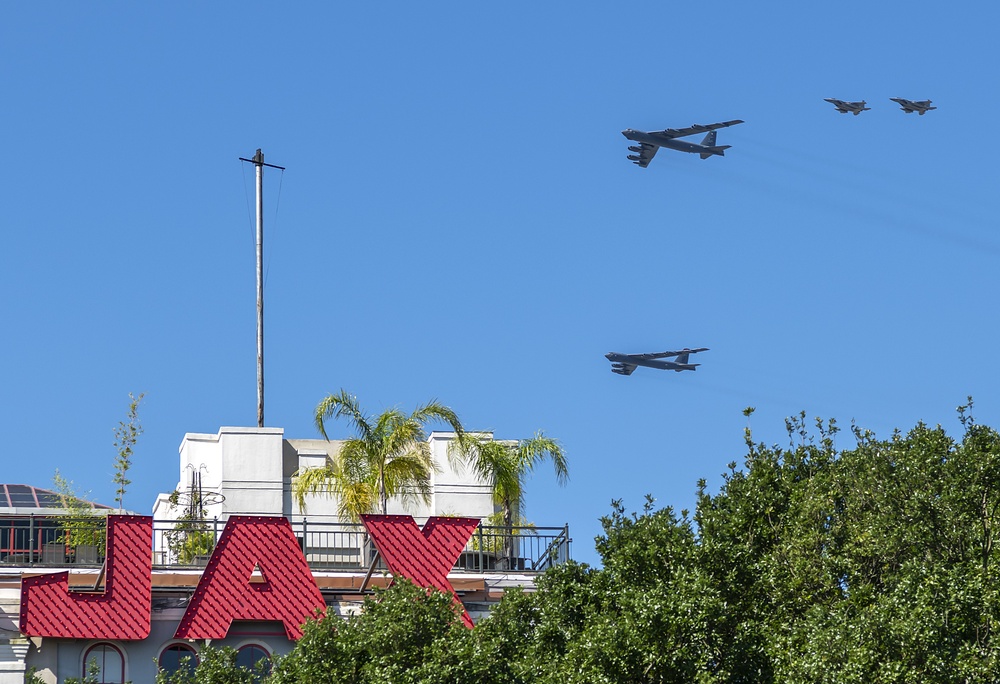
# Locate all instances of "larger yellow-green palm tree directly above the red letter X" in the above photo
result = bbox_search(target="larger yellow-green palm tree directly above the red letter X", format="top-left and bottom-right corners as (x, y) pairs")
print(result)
(294, 390), (464, 522)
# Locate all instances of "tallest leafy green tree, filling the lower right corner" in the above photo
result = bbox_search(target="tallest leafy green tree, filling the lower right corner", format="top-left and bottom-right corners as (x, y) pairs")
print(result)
(696, 404), (1000, 683)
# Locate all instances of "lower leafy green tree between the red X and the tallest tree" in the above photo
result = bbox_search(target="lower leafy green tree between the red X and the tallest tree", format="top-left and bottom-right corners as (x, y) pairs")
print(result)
(476, 499), (739, 684)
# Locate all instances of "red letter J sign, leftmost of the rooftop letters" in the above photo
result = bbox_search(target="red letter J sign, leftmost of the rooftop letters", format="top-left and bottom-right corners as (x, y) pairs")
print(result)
(20, 515), (153, 640)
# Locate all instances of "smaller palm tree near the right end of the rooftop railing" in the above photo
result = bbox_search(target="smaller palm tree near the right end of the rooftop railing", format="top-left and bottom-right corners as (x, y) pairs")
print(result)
(455, 432), (569, 529)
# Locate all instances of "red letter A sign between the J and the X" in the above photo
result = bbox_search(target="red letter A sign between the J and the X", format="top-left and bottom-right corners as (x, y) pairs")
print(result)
(174, 515), (326, 639)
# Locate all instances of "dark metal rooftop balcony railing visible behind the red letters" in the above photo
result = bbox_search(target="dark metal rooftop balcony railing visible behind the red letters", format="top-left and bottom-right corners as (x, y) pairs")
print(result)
(0, 515), (570, 573)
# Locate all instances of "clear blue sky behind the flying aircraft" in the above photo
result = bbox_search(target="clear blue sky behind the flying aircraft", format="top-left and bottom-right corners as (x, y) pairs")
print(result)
(0, 0), (1000, 562)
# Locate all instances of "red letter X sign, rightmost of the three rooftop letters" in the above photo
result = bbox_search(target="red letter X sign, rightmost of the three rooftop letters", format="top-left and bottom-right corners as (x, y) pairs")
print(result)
(361, 515), (479, 627)
